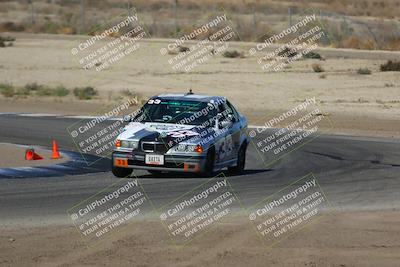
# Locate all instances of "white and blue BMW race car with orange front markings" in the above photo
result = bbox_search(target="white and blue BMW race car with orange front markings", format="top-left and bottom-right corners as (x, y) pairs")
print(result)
(112, 90), (249, 177)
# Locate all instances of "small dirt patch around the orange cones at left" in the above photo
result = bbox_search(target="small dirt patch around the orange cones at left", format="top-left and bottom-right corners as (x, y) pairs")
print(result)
(0, 143), (68, 168)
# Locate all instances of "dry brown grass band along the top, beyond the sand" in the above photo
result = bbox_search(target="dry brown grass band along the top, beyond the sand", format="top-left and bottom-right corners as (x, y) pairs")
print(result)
(0, 0), (400, 50)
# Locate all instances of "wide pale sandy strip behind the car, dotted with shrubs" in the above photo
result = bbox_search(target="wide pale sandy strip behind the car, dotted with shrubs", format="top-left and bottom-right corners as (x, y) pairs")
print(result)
(0, 34), (400, 138)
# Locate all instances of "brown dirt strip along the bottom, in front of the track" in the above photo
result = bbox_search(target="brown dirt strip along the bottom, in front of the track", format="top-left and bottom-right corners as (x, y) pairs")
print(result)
(0, 210), (400, 266)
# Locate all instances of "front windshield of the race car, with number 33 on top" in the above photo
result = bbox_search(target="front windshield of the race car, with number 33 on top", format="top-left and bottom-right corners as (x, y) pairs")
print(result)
(134, 99), (216, 125)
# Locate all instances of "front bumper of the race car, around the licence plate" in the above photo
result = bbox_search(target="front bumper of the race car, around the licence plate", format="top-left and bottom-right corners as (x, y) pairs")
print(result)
(111, 151), (206, 173)
